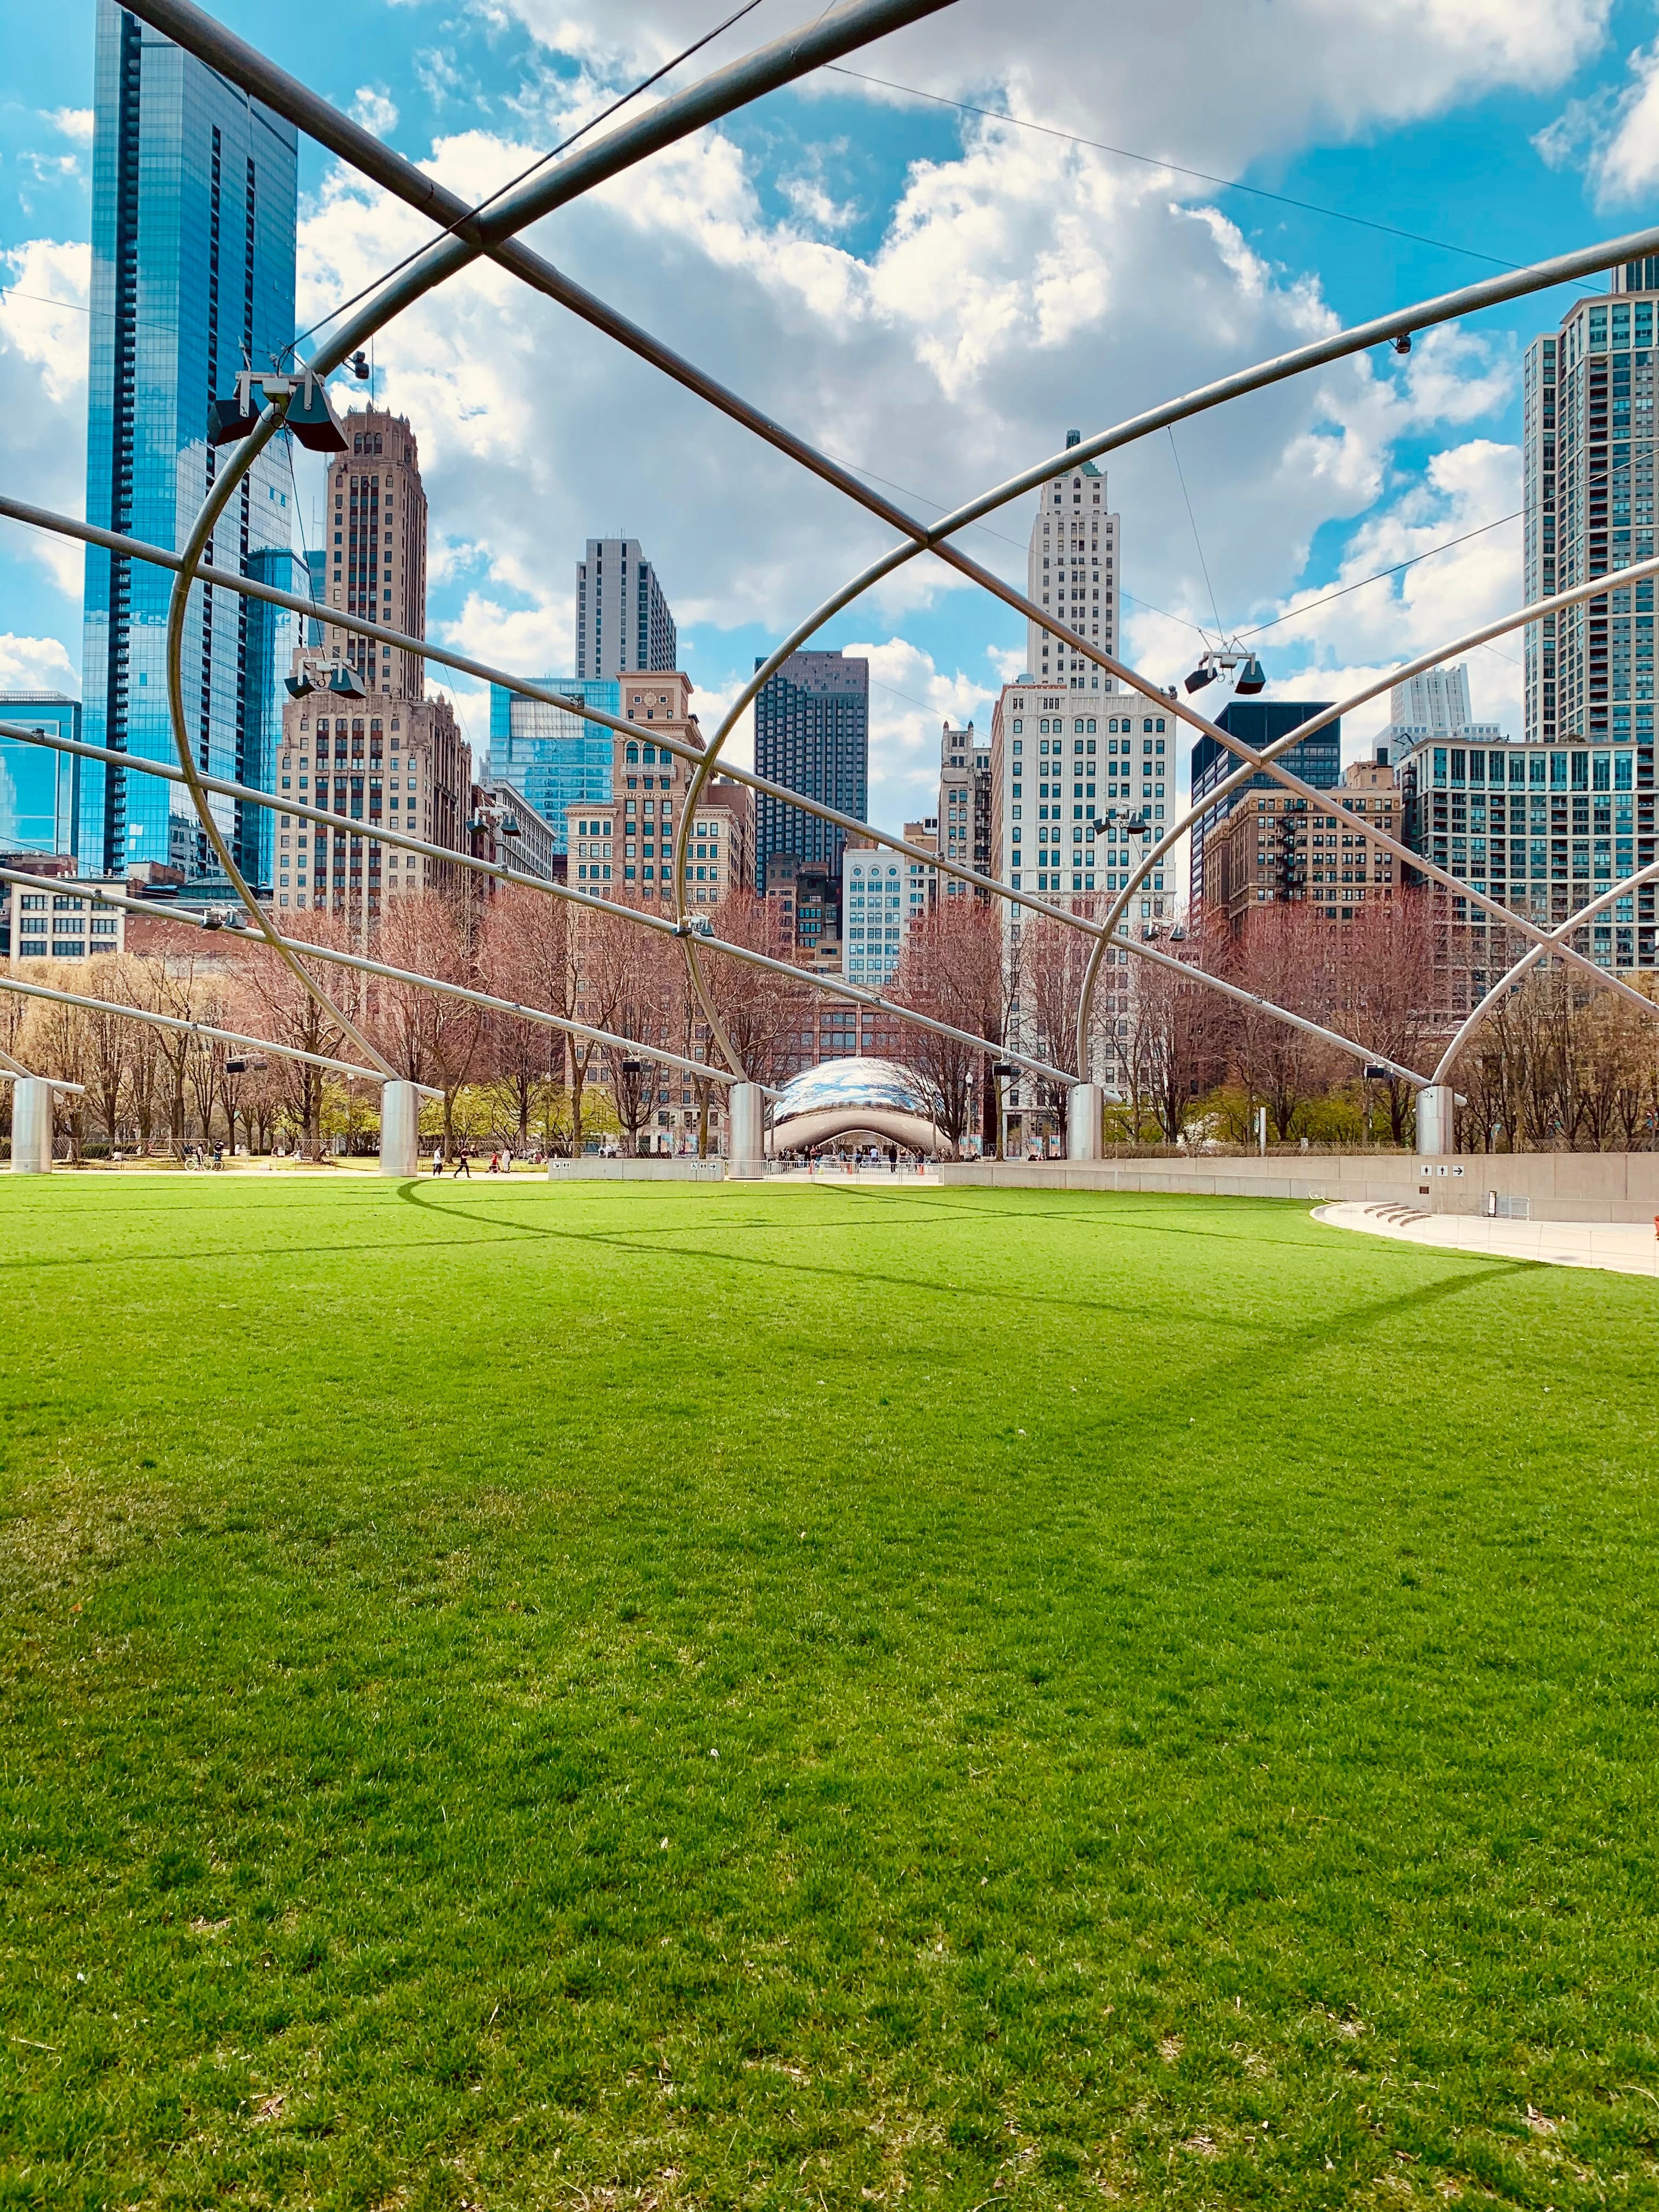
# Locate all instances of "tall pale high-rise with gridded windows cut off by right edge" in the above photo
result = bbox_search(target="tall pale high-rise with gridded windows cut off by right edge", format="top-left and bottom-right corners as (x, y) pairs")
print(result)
(1522, 257), (1659, 761)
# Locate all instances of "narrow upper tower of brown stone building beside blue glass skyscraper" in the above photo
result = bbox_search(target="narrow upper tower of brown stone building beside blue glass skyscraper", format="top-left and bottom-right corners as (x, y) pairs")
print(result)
(312, 407), (427, 699)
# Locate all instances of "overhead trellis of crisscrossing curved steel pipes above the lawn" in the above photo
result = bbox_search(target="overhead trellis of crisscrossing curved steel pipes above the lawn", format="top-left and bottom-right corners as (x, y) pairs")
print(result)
(0, 0), (1659, 1177)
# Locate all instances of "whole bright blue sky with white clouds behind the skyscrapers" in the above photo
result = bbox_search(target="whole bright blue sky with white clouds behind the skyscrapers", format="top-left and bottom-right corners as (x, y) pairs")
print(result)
(0, 0), (1659, 821)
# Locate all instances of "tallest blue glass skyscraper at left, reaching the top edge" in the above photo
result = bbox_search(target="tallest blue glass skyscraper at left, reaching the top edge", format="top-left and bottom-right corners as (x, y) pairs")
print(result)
(80, 0), (307, 881)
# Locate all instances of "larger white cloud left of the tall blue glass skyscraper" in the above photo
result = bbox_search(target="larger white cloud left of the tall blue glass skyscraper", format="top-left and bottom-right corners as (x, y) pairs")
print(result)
(0, 239), (93, 597)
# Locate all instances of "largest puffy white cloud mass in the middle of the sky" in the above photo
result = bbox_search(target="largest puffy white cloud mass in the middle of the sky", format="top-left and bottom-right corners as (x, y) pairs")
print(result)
(301, 112), (1509, 672)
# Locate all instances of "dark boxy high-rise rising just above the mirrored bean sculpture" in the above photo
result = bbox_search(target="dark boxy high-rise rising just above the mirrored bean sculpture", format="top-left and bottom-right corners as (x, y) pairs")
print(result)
(754, 650), (870, 891)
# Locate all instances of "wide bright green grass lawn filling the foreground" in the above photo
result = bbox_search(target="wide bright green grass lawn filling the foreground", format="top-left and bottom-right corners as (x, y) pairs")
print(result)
(0, 1177), (1659, 2212)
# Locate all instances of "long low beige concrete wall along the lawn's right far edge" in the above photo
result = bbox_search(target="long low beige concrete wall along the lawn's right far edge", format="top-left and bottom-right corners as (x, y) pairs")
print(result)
(938, 1153), (1659, 1221)
